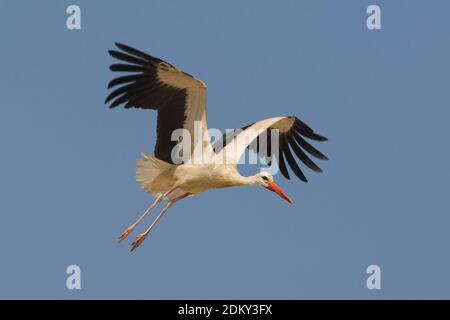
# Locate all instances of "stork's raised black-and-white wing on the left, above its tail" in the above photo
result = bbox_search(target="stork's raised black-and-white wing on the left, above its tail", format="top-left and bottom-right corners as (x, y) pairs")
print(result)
(105, 43), (213, 163)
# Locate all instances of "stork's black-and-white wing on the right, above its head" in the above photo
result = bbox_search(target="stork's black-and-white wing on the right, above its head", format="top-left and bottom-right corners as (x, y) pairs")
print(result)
(214, 117), (328, 182)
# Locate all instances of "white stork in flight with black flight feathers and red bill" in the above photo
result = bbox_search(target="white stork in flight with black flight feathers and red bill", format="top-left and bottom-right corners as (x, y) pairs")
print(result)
(105, 43), (327, 251)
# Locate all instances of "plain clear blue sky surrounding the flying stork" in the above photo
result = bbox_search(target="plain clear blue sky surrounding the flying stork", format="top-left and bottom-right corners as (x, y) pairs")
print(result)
(0, 0), (450, 299)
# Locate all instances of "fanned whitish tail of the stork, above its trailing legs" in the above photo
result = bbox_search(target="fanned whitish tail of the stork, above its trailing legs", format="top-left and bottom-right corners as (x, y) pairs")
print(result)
(136, 152), (175, 196)
